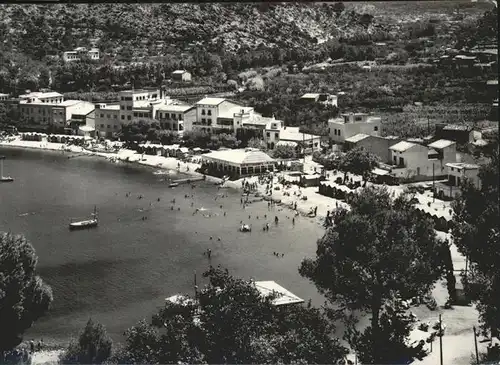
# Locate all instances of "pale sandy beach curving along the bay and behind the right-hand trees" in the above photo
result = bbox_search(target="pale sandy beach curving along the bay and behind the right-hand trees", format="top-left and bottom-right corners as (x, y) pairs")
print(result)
(0, 135), (485, 365)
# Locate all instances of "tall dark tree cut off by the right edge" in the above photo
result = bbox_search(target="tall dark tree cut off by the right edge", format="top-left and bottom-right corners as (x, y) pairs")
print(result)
(452, 139), (500, 335)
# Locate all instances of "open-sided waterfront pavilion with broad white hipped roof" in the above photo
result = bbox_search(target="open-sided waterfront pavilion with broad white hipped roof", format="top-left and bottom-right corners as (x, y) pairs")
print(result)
(201, 148), (276, 177)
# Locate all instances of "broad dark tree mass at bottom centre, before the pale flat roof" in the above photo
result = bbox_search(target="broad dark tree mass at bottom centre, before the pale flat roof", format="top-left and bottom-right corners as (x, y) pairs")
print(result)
(117, 268), (345, 364)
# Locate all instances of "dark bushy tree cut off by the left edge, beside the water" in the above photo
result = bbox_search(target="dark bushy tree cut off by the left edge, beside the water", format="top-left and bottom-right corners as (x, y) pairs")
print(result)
(0, 232), (53, 356)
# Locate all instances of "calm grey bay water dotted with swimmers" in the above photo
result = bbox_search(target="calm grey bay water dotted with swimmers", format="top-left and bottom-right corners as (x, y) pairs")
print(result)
(0, 149), (324, 339)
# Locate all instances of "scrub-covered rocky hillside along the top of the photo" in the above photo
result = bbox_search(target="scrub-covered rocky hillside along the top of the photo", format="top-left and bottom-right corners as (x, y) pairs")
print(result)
(0, 3), (390, 59)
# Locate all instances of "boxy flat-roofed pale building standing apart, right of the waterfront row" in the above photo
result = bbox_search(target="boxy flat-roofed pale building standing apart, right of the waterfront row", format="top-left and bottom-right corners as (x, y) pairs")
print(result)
(328, 113), (382, 143)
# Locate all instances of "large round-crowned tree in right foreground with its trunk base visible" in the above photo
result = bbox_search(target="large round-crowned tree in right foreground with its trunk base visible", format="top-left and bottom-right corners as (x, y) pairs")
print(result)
(299, 188), (443, 364)
